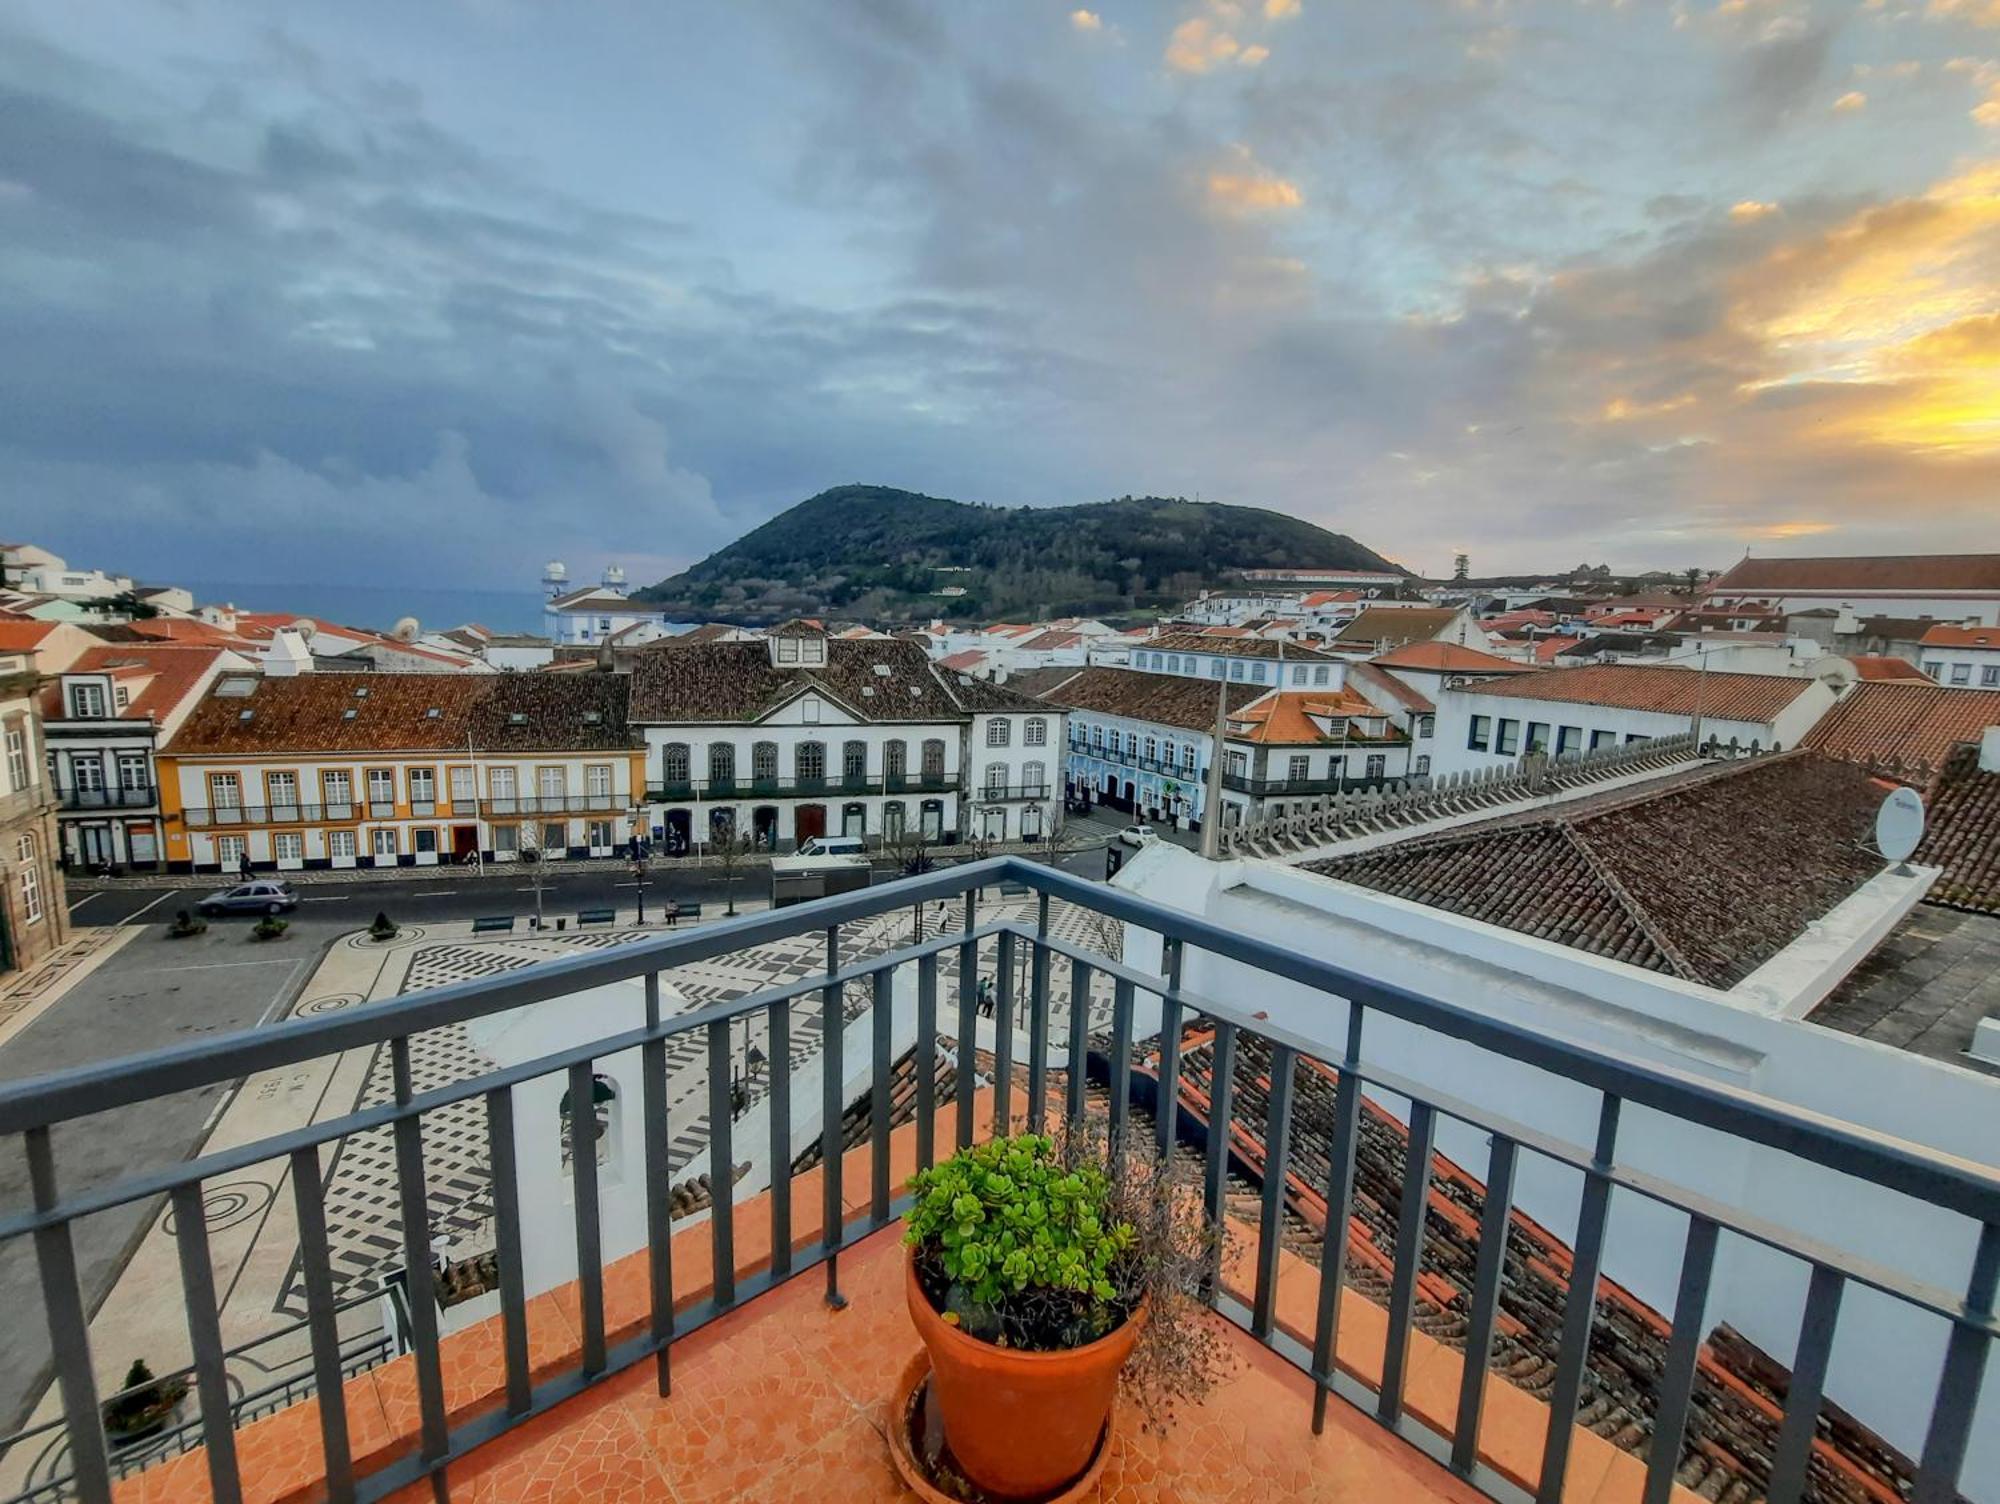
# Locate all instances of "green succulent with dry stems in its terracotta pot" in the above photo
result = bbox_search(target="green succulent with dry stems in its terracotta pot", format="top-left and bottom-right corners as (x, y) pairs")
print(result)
(904, 1124), (1222, 1498)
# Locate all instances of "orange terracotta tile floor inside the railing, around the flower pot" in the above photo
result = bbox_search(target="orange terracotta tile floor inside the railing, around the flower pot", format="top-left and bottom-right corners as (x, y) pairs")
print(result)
(398, 1228), (1480, 1504)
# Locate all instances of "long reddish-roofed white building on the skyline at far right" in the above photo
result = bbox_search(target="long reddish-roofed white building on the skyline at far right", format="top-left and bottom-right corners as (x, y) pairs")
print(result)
(1704, 554), (2000, 626)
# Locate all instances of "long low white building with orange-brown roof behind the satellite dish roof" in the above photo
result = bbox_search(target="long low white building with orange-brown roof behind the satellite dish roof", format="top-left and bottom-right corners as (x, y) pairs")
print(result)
(1432, 658), (1854, 774)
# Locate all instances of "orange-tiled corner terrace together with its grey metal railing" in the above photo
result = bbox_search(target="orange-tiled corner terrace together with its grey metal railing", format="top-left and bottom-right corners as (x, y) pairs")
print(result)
(0, 858), (2000, 1504)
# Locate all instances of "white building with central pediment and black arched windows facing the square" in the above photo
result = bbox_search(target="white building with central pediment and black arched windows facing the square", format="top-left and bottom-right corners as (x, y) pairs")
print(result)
(632, 622), (1062, 852)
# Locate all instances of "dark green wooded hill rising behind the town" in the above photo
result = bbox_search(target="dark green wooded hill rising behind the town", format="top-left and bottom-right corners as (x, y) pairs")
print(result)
(638, 486), (1394, 624)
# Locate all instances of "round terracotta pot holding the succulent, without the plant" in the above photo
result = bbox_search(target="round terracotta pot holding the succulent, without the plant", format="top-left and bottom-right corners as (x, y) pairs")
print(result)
(904, 1256), (1146, 1498)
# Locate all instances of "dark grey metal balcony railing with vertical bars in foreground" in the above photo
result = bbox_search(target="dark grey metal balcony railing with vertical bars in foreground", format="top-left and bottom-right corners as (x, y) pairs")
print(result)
(0, 858), (2000, 1504)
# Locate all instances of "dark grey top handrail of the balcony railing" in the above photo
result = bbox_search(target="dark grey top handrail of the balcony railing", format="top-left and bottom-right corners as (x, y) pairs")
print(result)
(0, 856), (2000, 1224)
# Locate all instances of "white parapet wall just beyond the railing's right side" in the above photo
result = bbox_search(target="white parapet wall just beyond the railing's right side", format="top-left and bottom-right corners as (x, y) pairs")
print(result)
(1116, 846), (2000, 1502)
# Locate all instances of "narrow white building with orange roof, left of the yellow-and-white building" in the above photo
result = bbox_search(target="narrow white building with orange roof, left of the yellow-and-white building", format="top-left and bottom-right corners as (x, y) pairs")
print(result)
(40, 642), (252, 872)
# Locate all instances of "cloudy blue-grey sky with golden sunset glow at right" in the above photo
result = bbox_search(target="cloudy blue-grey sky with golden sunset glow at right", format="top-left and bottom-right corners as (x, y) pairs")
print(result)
(0, 0), (2000, 586)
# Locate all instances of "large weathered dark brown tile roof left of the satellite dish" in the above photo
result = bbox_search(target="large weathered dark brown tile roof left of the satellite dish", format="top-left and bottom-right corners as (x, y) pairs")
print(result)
(1308, 752), (1884, 988)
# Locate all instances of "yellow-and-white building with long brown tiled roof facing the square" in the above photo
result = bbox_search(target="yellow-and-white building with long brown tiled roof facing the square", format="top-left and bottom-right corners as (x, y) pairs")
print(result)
(169, 672), (646, 874)
